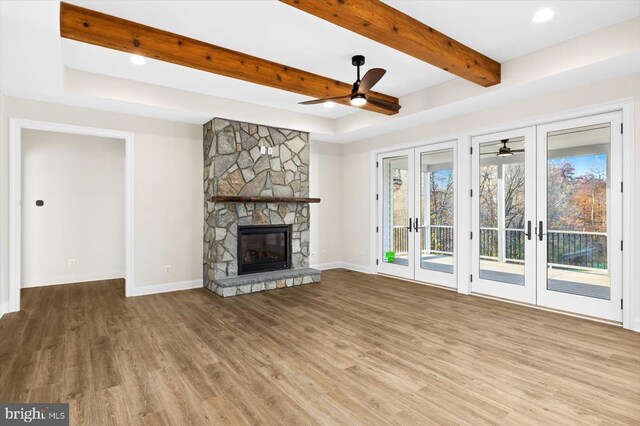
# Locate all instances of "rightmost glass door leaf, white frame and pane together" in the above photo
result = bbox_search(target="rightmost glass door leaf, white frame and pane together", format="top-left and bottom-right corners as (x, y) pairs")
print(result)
(538, 113), (622, 321)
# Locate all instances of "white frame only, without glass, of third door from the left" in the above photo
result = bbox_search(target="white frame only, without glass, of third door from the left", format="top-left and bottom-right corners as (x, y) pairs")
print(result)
(471, 126), (536, 304)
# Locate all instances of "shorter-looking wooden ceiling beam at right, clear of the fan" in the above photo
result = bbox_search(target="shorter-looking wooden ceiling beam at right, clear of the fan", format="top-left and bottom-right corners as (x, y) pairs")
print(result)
(280, 0), (500, 87)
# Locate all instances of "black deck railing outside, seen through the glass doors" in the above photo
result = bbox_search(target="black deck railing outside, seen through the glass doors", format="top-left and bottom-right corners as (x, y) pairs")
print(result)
(391, 225), (608, 269)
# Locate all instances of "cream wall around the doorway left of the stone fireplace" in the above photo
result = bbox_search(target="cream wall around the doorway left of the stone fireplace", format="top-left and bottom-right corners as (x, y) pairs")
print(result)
(0, 97), (204, 299)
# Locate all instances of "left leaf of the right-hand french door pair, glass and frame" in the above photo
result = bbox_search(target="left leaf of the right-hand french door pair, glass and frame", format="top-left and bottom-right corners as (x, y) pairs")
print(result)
(472, 128), (535, 303)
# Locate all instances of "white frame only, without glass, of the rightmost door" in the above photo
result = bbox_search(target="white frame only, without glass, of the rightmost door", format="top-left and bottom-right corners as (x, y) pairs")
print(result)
(536, 111), (624, 321)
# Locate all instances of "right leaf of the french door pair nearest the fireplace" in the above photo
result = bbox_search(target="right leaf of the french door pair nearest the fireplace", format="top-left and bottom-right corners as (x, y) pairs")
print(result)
(415, 142), (456, 287)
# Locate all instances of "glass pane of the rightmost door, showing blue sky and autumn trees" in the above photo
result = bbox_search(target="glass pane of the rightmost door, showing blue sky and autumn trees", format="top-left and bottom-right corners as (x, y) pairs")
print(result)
(547, 123), (611, 300)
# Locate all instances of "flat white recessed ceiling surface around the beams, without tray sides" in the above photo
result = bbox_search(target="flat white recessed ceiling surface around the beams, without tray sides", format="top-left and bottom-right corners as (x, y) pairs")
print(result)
(62, 0), (640, 118)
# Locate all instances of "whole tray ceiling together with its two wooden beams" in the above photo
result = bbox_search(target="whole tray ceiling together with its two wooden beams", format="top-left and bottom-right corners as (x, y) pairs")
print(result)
(0, 0), (640, 141)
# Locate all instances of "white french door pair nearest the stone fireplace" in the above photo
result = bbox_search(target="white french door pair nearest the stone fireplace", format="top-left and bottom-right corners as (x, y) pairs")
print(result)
(378, 142), (456, 288)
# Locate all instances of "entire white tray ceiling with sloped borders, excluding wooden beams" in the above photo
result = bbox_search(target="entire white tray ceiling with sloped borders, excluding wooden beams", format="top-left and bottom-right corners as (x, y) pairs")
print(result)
(0, 0), (640, 143)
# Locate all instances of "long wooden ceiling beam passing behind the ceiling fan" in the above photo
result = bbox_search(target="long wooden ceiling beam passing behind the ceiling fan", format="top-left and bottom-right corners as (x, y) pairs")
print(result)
(60, 2), (398, 115)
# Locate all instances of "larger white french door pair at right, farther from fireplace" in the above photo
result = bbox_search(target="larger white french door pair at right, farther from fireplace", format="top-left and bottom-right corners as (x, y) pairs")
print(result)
(471, 113), (622, 321)
